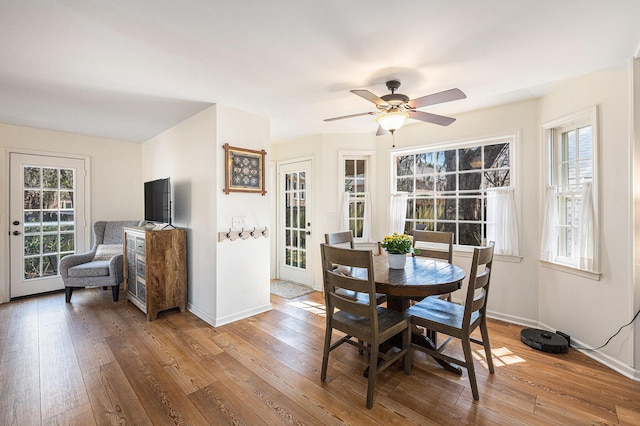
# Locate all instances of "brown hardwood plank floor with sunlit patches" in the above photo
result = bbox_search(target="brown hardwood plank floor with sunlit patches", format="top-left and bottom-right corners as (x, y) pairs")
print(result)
(0, 289), (640, 425)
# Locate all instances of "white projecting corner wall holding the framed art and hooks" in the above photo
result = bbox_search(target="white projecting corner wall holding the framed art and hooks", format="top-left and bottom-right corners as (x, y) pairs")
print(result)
(142, 105), (271, 326)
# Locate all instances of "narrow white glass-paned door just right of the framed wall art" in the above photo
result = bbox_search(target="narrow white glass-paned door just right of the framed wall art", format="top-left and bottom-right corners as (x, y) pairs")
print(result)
(278, 160), (315, 286)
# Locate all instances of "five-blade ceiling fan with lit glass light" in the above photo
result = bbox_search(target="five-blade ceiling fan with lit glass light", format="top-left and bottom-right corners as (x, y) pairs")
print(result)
(324, 80), (467, 135)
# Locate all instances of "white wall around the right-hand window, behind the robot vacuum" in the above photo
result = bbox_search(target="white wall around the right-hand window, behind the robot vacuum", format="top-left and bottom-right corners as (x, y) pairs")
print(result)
(539, 65), (634, 374)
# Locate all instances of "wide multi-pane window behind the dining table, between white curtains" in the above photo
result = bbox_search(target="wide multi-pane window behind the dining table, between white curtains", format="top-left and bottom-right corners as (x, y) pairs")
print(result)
(393, 136), (515, 246)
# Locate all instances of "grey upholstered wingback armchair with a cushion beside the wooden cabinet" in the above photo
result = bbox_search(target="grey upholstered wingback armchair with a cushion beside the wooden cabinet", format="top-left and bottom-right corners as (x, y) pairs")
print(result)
(59, 220), (140, 303)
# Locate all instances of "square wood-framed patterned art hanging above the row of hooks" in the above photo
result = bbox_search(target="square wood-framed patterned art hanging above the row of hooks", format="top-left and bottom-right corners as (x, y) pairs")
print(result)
(223, 143), (267, 195)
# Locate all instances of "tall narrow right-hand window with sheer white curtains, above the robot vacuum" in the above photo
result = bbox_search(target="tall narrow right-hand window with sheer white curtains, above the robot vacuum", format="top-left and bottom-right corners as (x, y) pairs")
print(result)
(541, 108), (598, 271)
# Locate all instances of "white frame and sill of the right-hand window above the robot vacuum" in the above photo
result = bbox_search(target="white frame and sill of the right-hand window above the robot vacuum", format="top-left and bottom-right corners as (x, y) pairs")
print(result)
(540, 105), (602, 280)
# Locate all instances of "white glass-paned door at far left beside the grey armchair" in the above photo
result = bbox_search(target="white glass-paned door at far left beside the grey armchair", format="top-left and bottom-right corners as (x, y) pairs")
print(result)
(9, 153), (85, 298)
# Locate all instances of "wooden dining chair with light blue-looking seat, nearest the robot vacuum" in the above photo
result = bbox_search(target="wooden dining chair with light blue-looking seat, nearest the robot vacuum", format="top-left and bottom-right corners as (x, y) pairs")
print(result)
(407, 243), (494, 400)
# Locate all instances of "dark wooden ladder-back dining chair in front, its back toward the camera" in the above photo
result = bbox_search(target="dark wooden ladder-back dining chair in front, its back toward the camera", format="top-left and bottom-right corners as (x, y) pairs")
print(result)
(320, 244), (411, 408)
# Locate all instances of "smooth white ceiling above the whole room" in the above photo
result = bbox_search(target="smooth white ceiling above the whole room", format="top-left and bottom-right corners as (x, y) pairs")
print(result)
(0, 0), (640, 142)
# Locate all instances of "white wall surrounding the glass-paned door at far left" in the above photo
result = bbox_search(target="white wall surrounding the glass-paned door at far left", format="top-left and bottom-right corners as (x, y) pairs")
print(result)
(0, 123), (143, 303)
